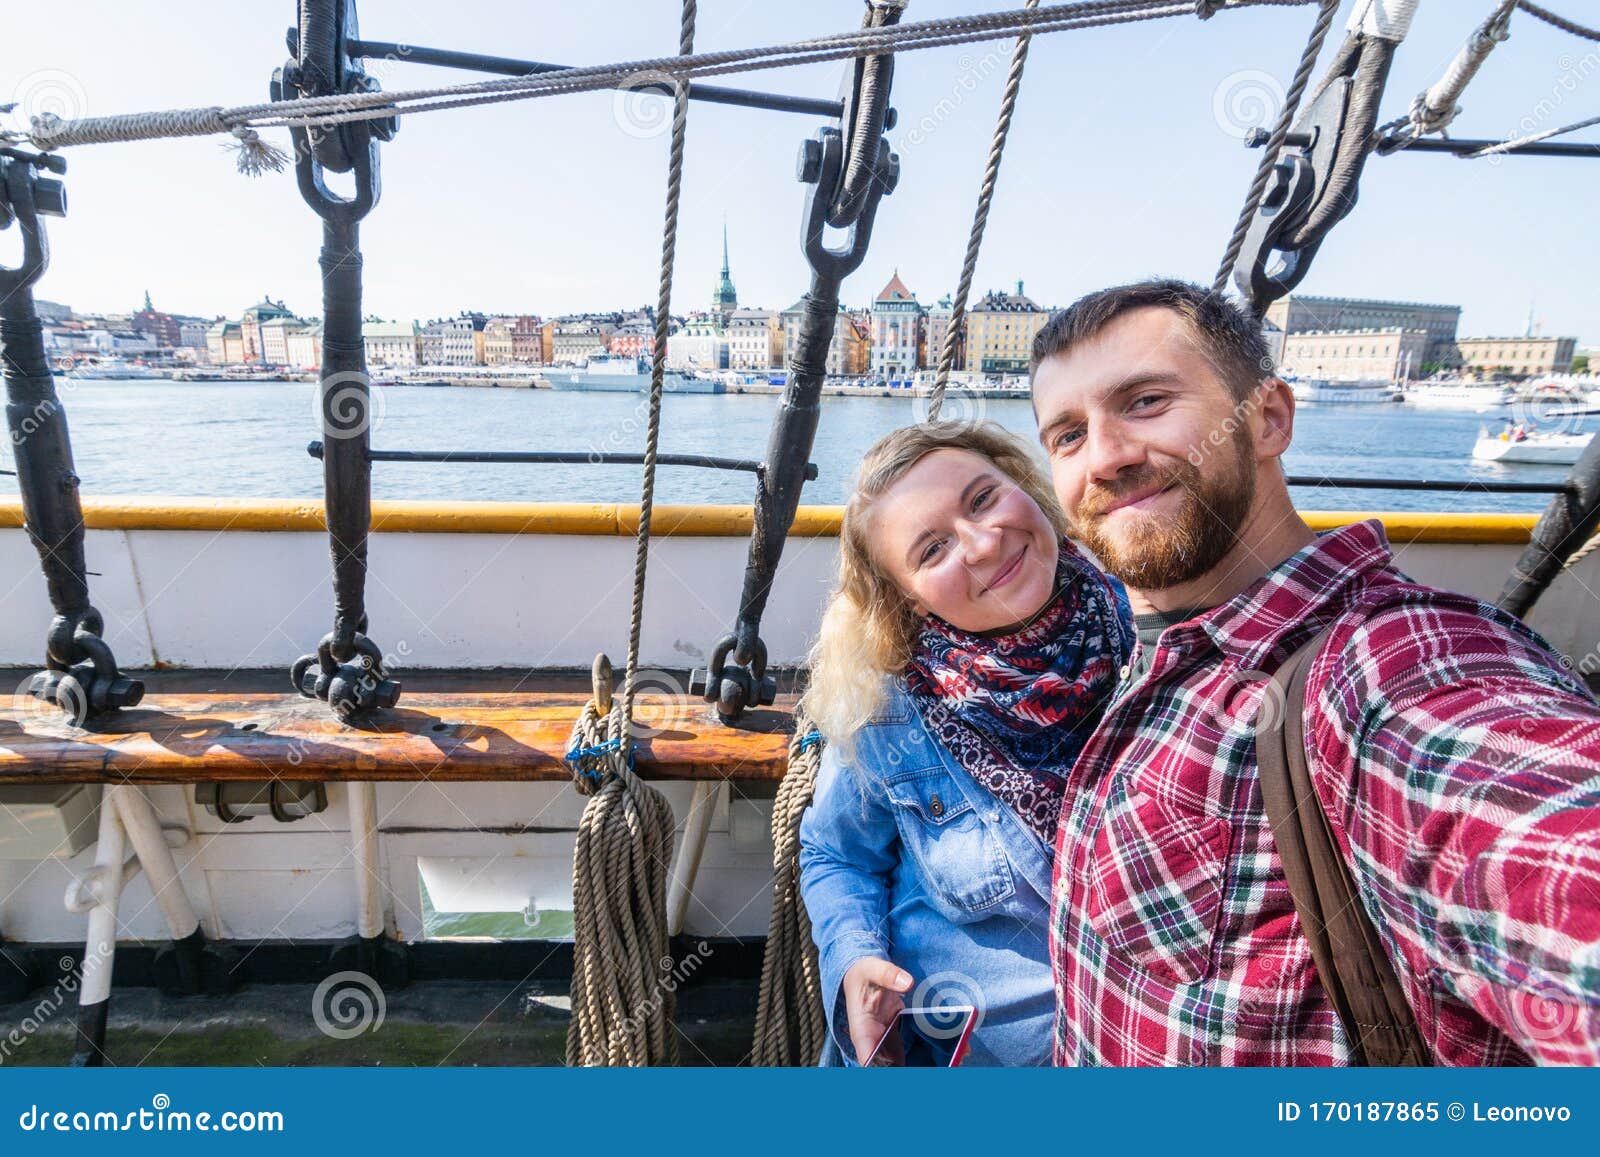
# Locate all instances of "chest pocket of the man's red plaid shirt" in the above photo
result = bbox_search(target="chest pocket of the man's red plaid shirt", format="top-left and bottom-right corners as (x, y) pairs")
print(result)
(1088, 783), (1230, 984)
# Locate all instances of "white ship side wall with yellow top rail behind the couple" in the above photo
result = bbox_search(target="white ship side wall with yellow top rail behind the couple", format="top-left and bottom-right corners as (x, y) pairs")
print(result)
(0, 499), (1600, 944)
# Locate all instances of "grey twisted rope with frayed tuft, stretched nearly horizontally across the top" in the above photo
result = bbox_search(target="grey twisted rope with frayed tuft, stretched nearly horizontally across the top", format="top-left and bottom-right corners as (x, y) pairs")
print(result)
(9, 0), (1315, 168)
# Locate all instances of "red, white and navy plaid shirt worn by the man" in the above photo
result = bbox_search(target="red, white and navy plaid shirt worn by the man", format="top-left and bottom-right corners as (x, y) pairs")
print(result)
(1050, 520), (1600, 1064)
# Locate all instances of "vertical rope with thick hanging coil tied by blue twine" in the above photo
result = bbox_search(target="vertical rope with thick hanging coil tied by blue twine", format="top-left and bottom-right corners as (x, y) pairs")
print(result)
(566, 0), (696, 1066)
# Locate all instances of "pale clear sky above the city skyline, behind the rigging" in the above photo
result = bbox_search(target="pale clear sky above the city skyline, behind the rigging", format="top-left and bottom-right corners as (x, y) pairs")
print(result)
(0, 0), (1600, 342)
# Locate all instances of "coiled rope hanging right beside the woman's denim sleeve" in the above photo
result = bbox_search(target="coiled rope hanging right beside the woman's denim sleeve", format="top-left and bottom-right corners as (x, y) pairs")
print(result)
(750, 723), (827, 1066)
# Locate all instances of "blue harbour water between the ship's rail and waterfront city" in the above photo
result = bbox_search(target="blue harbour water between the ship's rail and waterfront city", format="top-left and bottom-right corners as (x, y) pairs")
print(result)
(9, 379), (1600, 512)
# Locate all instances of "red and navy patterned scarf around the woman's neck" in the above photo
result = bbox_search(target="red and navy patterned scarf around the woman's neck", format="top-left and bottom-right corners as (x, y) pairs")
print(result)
(904, 539), (1133, 848)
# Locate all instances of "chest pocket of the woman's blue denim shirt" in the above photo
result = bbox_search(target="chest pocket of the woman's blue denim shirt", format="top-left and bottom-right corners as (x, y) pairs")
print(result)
(886, 768), (1016, 923)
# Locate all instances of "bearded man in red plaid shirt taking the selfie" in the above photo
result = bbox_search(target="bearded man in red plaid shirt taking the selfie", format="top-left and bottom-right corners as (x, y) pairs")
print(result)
(1032, 273), (1600, 1064)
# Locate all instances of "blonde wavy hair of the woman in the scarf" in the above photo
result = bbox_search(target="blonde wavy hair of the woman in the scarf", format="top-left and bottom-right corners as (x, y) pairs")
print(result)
(802, 421), (1066, 749)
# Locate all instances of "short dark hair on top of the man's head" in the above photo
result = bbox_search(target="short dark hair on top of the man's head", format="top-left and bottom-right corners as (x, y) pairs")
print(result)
(1029, 278), (1275, 402)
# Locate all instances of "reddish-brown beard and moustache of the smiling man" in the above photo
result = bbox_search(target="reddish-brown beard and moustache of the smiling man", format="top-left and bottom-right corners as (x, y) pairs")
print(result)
(1072, 435), (1256, 591)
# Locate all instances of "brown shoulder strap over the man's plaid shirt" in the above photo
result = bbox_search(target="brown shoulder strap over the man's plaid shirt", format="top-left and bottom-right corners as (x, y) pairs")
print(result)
(1256, 631), (1432, 1066)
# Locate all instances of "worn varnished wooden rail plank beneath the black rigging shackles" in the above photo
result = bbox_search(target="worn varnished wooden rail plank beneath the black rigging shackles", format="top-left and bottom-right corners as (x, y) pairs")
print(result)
(0, 671), (794, 784)
